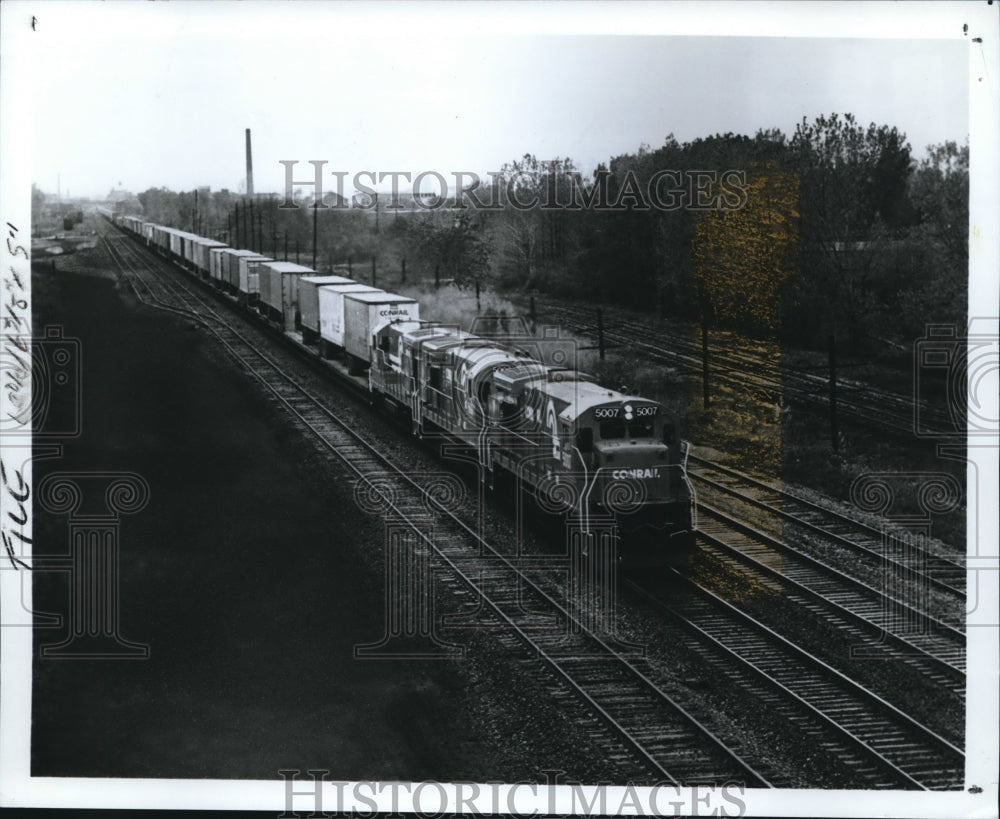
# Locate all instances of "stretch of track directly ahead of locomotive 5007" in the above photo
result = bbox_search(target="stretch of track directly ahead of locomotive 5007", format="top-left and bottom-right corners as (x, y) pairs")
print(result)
(627, 569), (965, 790)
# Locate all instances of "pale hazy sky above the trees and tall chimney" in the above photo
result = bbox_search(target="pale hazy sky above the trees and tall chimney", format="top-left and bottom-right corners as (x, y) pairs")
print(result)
(5, 0), (970, 197)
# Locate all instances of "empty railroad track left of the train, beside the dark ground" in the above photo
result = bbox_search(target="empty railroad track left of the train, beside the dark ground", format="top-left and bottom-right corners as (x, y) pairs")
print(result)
(99, 229), (769, 787)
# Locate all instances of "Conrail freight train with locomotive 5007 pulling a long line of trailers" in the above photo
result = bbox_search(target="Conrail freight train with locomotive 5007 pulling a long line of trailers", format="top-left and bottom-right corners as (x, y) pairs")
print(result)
(104, 212), (694, 565)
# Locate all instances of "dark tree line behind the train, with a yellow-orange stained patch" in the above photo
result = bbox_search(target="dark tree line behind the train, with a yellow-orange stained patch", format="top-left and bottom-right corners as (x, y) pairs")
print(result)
(121, 114), (969, 351)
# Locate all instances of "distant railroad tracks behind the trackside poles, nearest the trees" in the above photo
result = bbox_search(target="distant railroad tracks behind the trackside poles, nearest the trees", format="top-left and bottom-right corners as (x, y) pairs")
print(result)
(538, 303), (953, 437)
